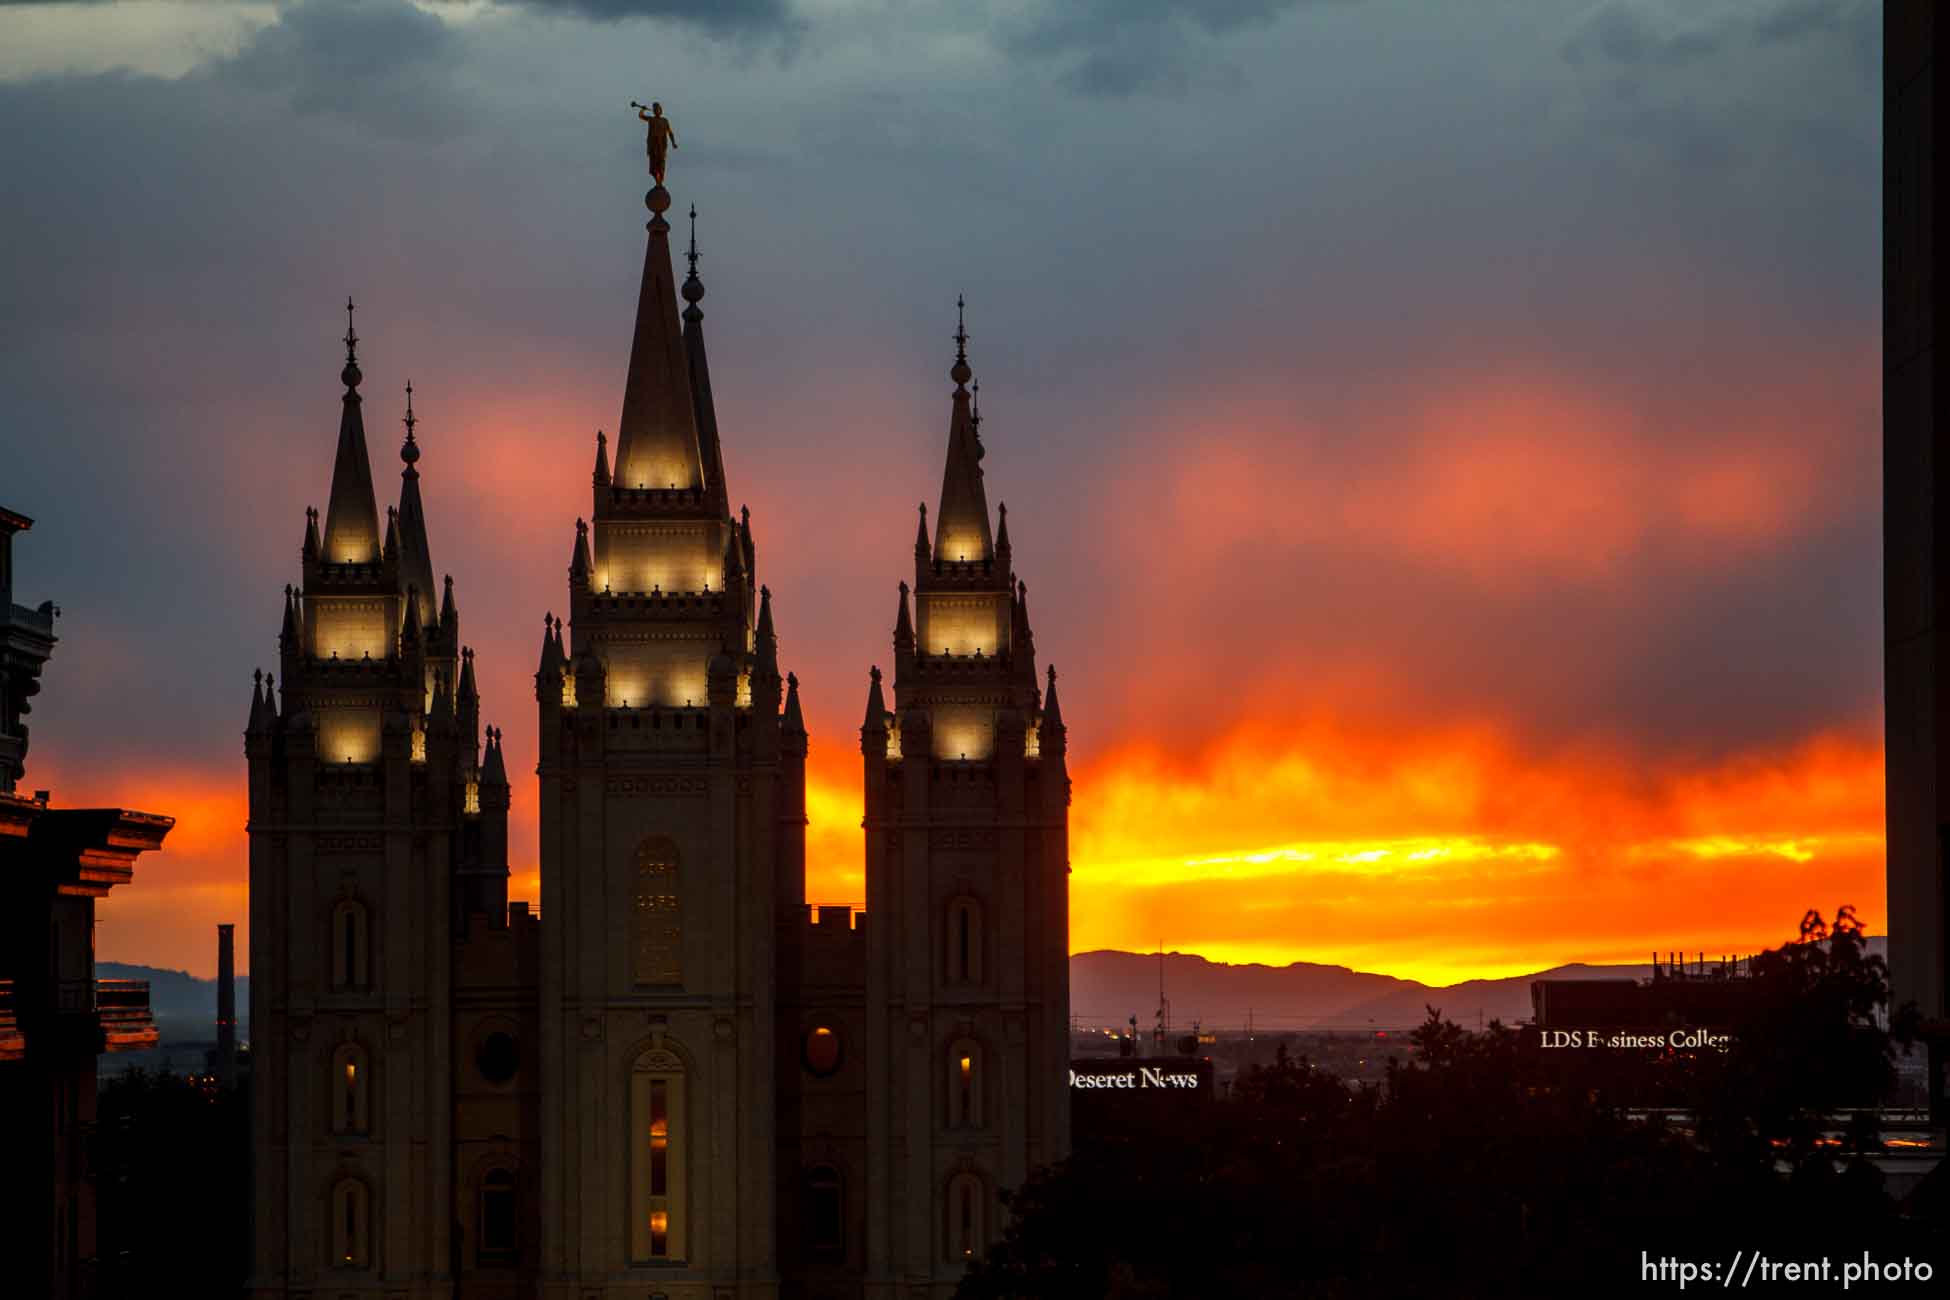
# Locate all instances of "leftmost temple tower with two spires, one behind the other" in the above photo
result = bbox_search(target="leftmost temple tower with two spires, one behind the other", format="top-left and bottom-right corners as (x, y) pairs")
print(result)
(244, 311), (507, 1296)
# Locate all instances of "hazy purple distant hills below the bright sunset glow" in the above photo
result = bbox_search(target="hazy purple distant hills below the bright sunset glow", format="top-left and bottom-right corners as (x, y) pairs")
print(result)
(1071, 936), (1890, 1029)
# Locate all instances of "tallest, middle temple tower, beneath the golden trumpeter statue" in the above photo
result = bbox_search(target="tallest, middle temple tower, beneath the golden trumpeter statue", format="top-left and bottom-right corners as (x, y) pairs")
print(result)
(534, 185), (805, 1300)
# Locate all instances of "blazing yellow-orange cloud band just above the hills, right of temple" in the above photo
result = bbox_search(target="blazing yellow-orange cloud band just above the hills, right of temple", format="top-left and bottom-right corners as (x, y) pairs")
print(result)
(1071, 721), (1884, 982)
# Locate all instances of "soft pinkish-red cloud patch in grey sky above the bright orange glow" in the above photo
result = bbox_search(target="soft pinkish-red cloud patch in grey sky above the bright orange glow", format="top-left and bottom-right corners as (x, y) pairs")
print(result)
(1138, 359), (1872, 589)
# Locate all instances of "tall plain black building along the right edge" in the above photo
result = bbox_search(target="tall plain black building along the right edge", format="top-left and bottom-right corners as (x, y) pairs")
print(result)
(1882, 0), (1950, 1117)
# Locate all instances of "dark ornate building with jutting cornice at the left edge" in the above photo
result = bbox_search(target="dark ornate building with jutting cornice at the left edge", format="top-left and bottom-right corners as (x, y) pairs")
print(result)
(0, 509), (176, 1296)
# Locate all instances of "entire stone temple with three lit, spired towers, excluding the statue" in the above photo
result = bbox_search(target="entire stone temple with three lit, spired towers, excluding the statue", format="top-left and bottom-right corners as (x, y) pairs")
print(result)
(246, 185), (1069, 1300)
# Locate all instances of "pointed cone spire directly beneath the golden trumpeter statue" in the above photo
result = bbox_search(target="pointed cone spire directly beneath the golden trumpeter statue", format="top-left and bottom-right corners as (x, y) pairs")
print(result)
(614, 185), (706, 489)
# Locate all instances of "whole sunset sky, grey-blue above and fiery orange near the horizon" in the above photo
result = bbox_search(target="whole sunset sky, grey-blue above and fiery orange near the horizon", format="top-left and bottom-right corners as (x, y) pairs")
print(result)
(0, 0), (1888, 982)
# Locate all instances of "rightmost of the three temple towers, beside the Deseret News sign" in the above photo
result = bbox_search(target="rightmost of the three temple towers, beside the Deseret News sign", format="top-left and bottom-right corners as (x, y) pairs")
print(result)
(860, 304), (1071, 1296)
